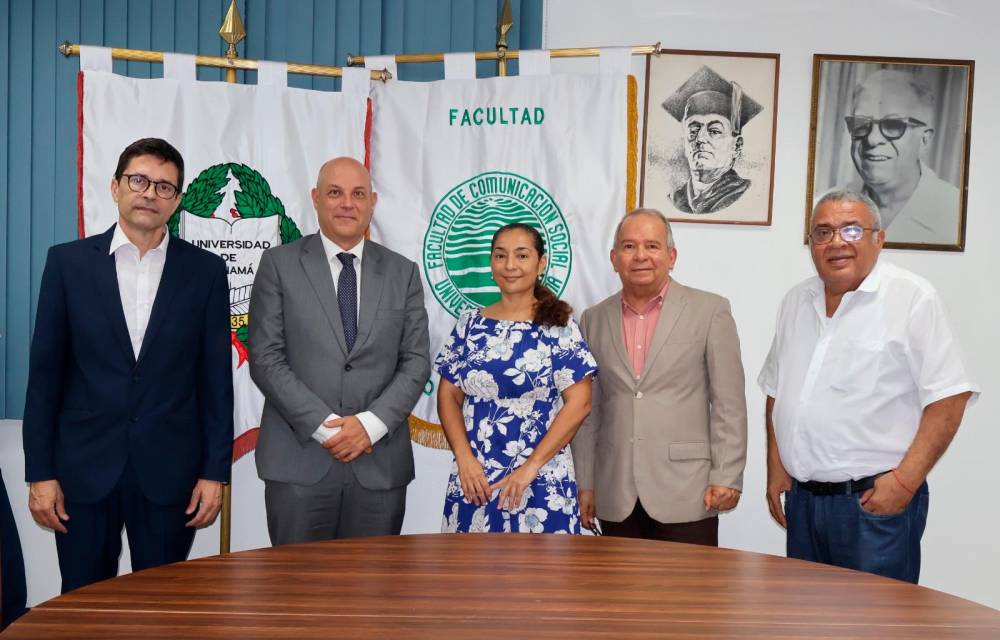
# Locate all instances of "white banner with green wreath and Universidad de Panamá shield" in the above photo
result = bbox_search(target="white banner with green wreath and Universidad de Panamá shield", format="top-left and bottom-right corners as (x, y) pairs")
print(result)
(80, 71), (368, 460)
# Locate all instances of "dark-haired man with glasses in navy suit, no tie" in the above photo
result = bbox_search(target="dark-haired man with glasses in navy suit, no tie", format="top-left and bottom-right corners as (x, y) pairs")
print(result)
(24, 138), (233, 593)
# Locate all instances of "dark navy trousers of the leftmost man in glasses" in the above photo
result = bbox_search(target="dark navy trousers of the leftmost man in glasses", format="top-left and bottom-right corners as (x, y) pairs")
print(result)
(55, 462), (194, 593)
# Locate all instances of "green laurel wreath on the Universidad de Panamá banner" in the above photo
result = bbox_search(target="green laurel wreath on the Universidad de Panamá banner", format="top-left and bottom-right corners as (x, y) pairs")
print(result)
(167, 162), (302, 346)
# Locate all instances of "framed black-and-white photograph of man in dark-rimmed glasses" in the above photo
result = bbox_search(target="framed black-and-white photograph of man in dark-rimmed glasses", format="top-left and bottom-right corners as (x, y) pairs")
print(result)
(803, 54), (975, 251)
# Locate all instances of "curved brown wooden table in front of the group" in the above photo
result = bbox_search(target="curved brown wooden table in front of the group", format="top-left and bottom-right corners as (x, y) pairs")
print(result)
(3, 534), (1000, 640)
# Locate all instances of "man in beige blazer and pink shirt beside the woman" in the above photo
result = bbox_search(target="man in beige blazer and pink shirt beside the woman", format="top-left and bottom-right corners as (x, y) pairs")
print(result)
(572, 209), (747, 546)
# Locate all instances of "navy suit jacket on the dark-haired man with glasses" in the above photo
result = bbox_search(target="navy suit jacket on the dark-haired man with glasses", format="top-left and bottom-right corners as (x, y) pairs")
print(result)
(23, 227), (233, 505)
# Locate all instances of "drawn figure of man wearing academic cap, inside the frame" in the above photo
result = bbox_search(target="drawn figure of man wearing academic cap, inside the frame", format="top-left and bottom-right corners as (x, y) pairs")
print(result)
(663, 66), (763, 214)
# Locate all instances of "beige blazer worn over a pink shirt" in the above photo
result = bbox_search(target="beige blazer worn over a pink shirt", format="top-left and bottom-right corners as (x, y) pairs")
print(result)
(572, 281), (747, 523)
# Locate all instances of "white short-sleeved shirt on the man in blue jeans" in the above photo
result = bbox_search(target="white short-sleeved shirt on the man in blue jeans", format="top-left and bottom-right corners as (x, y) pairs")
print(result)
(757, 261), (979, 482)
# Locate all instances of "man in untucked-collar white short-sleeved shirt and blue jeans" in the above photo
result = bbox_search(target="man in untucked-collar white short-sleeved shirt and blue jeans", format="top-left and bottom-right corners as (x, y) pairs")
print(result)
(758, 191), (978, 583)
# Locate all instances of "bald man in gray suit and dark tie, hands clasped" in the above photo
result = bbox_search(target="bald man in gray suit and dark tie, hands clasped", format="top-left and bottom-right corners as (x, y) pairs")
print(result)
(249, 158), (430, 545)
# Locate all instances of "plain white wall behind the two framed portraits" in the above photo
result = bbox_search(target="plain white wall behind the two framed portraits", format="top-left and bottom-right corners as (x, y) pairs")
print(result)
(545, 0), (1000, 608)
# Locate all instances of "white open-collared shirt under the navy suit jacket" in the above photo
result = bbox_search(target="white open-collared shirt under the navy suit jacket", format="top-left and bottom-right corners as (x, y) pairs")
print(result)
(108, 225), (170, 359)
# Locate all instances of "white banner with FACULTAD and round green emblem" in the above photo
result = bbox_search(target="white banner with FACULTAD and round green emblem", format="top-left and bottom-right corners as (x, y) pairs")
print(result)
(372, 74), (628, 458)
